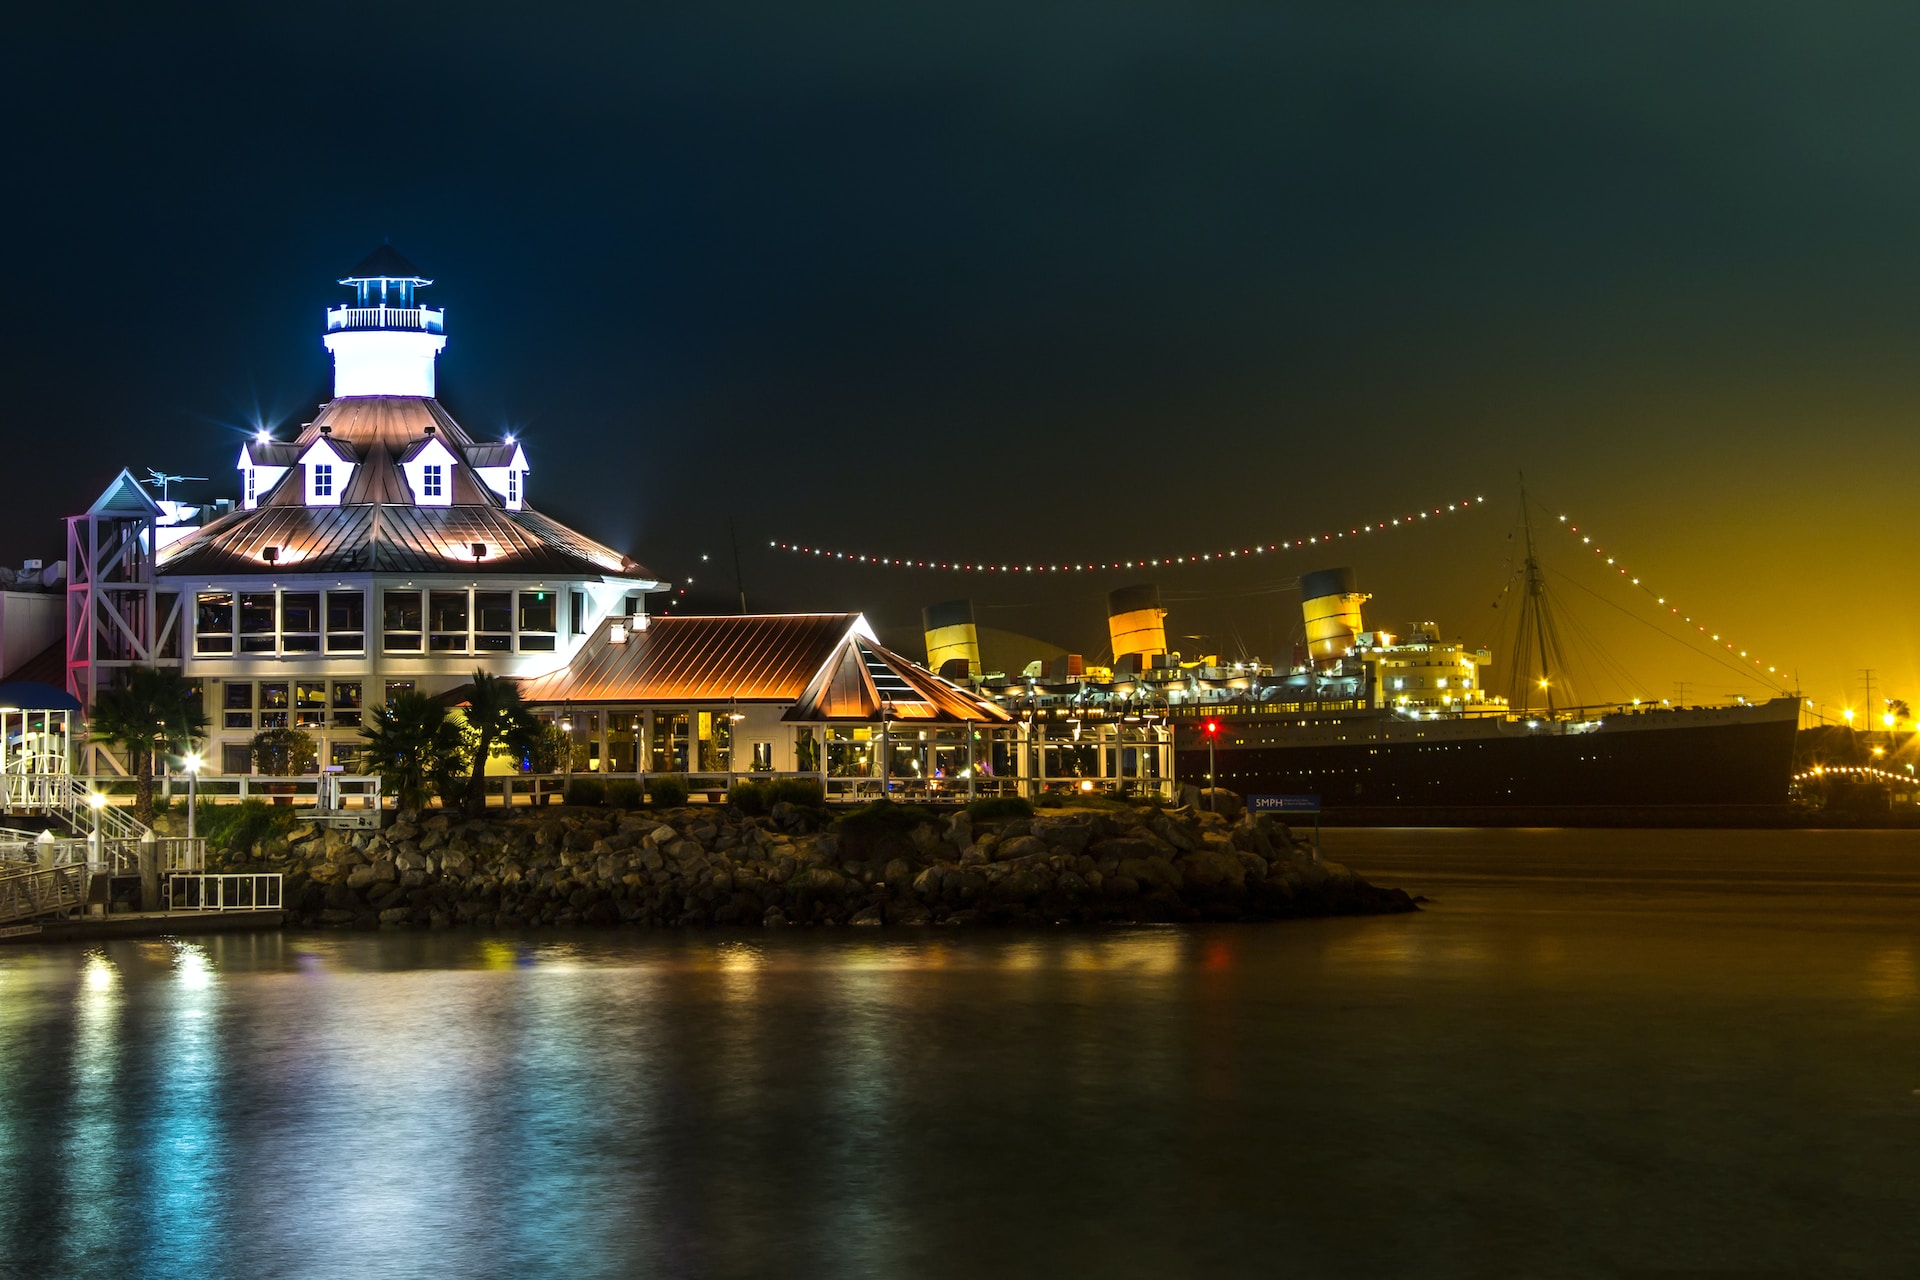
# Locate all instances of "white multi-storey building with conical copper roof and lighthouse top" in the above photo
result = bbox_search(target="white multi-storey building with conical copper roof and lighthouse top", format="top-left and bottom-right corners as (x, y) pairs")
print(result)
(82, 246), (664, 773)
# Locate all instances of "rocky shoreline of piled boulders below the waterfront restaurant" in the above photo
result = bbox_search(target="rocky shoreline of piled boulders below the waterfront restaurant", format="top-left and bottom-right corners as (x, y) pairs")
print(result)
(172, 793), (1417, 929)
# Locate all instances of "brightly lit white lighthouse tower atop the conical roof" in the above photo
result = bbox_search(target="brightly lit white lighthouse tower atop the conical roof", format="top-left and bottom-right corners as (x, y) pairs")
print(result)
(326, 244), (447, 397)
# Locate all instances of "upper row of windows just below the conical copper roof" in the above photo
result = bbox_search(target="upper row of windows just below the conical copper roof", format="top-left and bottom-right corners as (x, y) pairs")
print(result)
(194, 587), (588, 656)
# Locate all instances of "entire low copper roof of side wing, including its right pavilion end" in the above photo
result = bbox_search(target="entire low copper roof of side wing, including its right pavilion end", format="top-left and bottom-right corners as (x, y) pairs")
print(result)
(520, 614), (1008, 722)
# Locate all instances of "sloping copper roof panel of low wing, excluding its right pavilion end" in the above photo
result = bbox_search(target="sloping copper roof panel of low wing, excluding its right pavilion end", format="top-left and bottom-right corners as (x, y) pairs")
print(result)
(520, 614), (860, 702)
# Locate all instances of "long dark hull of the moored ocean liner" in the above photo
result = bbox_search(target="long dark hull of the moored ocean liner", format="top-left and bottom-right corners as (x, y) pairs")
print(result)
(1175, 699), (1799, 810)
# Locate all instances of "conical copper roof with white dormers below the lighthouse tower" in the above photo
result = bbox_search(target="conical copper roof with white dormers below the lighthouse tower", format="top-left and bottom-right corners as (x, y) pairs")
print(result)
(159, 395), (653, 580)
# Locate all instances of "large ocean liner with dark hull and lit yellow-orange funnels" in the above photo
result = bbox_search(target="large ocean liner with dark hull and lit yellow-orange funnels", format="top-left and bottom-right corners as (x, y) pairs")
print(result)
(967, 510), (1799, 812)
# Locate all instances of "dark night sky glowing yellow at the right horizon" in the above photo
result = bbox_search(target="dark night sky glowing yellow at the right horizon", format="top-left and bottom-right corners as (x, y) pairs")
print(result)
(0, 0), (1920, 704)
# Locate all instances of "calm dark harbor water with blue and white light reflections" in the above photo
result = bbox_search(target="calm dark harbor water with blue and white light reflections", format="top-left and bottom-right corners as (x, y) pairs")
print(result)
(0, 831), (1920, 1280)
